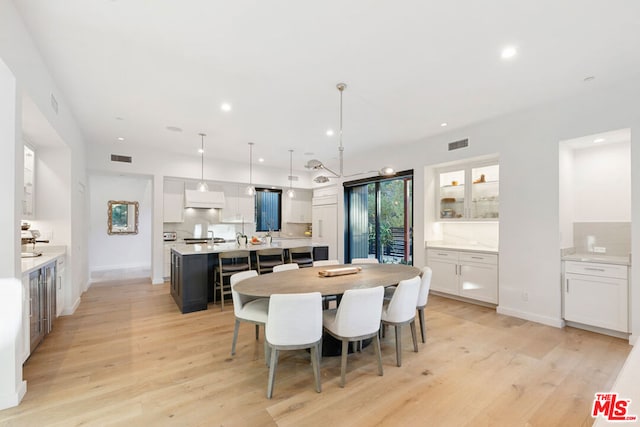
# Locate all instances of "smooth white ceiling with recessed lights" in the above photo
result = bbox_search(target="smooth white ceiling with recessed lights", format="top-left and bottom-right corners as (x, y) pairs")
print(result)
(15, 0), (640, 169)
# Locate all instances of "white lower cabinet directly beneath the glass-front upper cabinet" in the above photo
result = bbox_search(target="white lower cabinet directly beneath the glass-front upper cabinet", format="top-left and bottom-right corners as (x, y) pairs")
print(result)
(427, 249), (498, 304)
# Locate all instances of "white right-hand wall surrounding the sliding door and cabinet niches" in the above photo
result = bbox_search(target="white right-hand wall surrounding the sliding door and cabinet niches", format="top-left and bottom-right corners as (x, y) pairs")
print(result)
(338, 80), (640, 341)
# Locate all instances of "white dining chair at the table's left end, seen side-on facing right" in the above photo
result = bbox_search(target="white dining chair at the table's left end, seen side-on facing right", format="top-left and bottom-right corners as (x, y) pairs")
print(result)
(229, 270), (269, 356)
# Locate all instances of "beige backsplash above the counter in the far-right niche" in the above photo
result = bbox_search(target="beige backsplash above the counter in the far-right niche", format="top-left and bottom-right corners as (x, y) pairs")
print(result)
(573, 222), (631, 256)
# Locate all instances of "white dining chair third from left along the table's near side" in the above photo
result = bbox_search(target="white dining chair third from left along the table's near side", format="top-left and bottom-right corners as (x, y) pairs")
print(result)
(382, 276), (421, 366)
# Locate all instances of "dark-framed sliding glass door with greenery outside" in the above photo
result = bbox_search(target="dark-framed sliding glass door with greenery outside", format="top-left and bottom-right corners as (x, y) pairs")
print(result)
(344, 171), (413, 264)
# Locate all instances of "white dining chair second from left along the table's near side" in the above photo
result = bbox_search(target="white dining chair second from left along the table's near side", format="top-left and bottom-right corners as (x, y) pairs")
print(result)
(322, 286), (384, 387)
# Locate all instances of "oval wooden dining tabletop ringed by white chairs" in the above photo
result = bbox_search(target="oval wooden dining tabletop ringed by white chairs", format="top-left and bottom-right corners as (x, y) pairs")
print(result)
(234, 264), (420, 297)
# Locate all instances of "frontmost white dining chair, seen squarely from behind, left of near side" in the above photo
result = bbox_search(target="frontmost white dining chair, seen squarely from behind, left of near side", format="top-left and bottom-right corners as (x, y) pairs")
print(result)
(265, 292), (322, 399)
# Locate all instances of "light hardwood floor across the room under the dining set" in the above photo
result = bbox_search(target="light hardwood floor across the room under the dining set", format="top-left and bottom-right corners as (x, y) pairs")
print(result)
(0, 279), (630, 427)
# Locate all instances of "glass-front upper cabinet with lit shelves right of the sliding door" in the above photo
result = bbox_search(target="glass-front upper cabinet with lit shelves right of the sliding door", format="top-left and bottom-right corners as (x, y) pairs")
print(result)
(436, 161), (500, 221)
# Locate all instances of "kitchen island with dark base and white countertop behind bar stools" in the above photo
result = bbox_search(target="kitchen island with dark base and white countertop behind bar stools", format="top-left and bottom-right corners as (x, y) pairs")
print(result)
(171, 239), (328, 313)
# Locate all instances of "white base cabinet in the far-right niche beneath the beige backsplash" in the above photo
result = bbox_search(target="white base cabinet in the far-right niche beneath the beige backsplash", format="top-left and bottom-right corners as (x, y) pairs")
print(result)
(563, 261), (629, 332)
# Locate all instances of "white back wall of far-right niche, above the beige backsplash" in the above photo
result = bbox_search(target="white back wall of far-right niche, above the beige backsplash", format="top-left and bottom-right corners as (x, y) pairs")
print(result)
(573, 142), (631, 222)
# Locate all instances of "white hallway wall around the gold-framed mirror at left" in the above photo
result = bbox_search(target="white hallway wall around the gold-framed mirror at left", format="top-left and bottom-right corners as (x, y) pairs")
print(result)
(89, 175), (153, 272)
